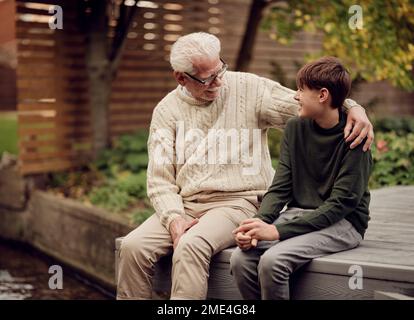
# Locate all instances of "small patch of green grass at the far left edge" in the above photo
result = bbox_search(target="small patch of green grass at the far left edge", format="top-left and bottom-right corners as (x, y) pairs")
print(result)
(0, 112), (18, 156)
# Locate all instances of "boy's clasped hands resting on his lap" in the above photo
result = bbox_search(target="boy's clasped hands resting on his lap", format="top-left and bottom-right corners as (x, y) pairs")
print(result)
(232, 218), (279, 250)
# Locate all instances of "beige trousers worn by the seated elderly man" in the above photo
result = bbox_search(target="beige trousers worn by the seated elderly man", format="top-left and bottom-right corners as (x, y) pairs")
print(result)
(117, 197), (259, 299)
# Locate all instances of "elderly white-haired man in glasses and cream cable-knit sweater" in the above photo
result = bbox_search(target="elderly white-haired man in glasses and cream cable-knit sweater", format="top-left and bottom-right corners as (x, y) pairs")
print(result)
(117, 33), (374, 299)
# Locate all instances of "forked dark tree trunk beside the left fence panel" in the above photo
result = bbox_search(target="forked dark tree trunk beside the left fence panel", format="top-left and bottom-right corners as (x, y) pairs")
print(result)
(80, 0), (137, 157)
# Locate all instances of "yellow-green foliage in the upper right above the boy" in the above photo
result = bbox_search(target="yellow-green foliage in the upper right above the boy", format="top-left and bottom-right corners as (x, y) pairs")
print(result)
(263, 0), (414, 90)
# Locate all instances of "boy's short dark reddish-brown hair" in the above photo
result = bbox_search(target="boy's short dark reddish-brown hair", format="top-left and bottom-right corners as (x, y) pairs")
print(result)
(296, 57), (351, 108)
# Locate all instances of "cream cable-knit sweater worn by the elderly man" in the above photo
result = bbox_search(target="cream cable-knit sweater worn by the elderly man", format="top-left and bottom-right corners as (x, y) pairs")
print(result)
(147, 71), (355, 230)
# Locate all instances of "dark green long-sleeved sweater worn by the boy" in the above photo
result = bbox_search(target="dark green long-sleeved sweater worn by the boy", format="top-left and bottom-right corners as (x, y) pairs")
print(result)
(256, 111), (372, 240)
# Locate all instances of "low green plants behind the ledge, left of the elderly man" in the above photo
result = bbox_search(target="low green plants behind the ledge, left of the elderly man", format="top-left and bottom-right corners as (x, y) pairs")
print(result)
(50, 131), (153, 224)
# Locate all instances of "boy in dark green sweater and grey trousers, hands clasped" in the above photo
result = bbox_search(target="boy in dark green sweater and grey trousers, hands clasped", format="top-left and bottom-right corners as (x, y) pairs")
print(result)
(230, 57), (372, 299)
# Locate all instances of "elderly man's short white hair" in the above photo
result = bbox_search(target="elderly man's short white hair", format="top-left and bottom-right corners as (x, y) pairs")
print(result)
(170, 32), (221, 74)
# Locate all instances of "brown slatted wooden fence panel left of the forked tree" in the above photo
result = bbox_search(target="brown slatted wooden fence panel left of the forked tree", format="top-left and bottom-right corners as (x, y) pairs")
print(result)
(16, 0), (91, 174)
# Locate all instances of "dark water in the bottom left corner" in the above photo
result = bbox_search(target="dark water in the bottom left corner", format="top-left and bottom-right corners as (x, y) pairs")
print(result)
(0, 240), (113, 300)
